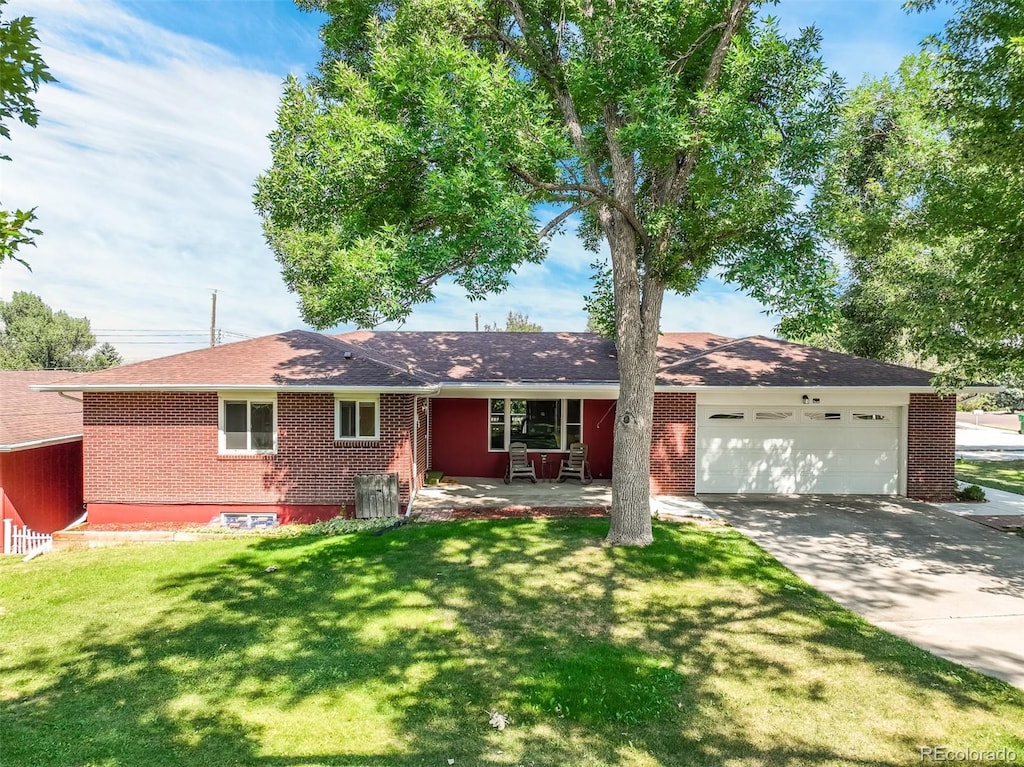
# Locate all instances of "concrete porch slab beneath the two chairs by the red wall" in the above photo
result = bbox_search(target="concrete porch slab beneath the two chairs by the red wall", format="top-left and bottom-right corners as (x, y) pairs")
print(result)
(413, 477), (611, 510)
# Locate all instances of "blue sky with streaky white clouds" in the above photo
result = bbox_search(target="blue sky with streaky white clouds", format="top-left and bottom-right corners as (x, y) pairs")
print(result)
(0, 0), (948, 359)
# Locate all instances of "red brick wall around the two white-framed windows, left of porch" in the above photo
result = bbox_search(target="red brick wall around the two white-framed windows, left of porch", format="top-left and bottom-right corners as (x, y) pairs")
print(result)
(83, 392), (414, 505)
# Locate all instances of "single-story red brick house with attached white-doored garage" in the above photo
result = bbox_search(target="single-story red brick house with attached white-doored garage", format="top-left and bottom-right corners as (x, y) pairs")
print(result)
(39, 331), (955, 522)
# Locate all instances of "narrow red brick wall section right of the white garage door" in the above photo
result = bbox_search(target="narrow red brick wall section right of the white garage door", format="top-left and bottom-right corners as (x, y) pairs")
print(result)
(906, 394), (956, 501)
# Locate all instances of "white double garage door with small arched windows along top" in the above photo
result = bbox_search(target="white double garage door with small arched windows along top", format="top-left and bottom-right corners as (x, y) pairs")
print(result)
(696, 406), (900, 495)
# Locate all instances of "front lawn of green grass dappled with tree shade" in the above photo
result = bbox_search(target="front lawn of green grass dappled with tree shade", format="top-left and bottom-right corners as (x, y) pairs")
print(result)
(0, 518), (1024, 767)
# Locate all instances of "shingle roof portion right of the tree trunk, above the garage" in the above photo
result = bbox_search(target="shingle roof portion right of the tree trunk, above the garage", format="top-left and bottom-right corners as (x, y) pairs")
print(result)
(657, 336), (932, 388)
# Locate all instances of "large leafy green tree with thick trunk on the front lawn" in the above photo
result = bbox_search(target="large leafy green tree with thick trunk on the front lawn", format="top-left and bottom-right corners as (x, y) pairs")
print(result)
(255, 0), (842, 544)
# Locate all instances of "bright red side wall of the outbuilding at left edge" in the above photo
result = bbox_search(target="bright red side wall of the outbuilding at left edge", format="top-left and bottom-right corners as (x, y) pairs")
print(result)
(0, 439), (82, 532)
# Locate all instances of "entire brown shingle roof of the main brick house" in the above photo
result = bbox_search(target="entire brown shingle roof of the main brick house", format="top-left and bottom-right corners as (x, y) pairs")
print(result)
(42, 330), (931, 395)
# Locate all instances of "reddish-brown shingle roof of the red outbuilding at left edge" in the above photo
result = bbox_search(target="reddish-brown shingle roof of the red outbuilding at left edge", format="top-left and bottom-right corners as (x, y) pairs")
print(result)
(0, 371), (82, 452)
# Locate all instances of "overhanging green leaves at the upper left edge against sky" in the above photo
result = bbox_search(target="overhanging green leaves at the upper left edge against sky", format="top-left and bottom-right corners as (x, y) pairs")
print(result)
(0, 0), (54, 266)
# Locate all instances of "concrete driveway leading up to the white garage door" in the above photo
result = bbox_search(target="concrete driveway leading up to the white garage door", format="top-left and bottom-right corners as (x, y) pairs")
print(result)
(700, 496), (1024, 689)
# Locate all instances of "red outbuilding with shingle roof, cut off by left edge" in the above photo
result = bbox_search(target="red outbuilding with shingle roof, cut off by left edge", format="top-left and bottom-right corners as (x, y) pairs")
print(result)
(0, 370), (83, 532)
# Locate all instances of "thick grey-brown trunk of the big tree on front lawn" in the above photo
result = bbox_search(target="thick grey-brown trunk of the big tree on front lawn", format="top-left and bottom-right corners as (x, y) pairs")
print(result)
(606, 211), (664, 546)
